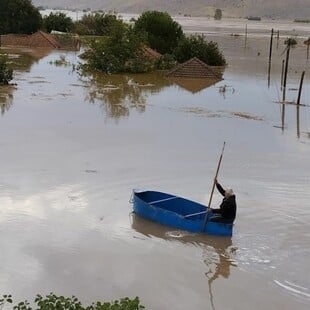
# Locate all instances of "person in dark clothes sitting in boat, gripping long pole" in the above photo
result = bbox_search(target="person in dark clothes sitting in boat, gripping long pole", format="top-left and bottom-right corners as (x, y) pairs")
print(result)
(210, 179), (237, 224)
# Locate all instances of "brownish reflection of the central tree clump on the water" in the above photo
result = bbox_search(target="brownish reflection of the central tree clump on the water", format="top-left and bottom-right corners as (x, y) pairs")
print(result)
(81, 72), (171, 118)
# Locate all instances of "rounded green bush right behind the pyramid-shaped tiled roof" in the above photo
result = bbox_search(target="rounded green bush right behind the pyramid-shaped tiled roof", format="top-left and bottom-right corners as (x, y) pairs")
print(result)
(174, 35), (226, 66)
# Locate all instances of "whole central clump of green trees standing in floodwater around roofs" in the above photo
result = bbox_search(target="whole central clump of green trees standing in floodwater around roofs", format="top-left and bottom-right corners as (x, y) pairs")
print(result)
(83, 11), (226, 73)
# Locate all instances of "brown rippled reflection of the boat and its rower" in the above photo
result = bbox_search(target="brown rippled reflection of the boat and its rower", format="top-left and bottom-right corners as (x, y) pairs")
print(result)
(131, 213), (237, 309)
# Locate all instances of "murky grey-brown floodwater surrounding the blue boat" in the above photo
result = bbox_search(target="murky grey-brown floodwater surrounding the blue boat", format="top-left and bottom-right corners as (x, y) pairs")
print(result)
(0, 24), (310, 310)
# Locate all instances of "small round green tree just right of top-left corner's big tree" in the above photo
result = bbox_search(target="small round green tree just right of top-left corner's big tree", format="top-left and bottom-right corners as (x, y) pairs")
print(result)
(43, 12), (73, 32)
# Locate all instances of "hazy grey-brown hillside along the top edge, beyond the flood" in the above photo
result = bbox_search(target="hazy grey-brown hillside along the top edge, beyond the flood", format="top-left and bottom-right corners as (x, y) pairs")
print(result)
(32, 0), (310, 19)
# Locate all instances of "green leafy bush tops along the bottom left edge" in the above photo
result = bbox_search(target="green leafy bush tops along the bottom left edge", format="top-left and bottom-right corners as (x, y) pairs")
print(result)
(0, 293), (145, 310)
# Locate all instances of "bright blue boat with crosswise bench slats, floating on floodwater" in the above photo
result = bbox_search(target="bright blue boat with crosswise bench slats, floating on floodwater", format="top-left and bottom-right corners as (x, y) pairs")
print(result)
(132, 190), (233, 236)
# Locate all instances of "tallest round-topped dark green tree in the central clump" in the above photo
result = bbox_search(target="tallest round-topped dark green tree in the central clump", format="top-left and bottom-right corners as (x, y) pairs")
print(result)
(134, 11), (184, 54)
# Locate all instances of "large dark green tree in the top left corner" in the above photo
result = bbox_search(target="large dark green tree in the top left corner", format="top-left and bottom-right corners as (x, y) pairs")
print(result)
(0, 0), (42, 34)
